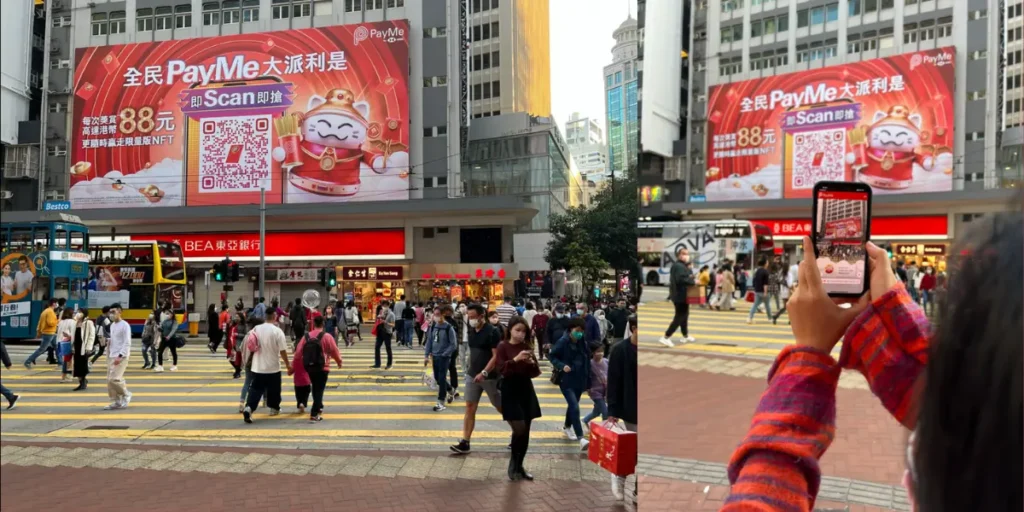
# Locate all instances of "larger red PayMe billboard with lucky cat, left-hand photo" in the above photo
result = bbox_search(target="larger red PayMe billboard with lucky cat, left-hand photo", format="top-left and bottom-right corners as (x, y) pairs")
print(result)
(70, 20), (410, 209)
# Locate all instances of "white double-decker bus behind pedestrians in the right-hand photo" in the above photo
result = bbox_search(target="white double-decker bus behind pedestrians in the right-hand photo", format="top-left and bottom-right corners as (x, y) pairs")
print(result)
(637, 220), (775, 286)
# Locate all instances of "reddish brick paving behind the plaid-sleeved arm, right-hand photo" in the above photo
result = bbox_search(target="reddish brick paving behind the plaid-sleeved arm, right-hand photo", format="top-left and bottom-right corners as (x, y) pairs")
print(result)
(639, 366), (907, 487)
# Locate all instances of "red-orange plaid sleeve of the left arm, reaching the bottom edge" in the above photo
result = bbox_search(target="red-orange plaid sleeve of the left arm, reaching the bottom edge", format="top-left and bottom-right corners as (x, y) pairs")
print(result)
(722, 345), (841, 512)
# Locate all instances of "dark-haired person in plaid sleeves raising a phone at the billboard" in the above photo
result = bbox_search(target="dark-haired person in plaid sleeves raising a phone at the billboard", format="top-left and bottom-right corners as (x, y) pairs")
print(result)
(723, 220), (1024, 512)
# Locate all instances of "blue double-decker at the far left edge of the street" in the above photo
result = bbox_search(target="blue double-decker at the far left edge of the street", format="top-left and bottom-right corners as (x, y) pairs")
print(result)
(0, 212), (89, 340)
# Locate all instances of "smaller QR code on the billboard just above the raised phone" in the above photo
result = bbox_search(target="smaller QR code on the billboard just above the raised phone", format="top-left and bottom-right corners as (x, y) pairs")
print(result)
(791, 128), (846, 188)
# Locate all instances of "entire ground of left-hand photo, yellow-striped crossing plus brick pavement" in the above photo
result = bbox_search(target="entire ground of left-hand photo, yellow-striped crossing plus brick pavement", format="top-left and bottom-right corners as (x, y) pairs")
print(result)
(0, 335), (621, 510)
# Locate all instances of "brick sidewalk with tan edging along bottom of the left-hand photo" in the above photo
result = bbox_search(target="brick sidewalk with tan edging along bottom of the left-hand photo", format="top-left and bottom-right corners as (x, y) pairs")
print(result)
(0, 443), (625, 512)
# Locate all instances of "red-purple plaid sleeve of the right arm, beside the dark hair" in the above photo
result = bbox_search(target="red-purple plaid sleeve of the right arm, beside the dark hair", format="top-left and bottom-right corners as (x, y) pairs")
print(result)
(839, 285), (931, 429)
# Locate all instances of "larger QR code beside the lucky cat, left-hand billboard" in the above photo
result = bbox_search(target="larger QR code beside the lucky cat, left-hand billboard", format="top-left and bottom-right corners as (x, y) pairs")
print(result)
(199, 116), (272, 193)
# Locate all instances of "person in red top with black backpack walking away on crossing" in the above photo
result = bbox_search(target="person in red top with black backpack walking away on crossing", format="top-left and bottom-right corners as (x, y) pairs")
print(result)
(289, 314), (341, 423)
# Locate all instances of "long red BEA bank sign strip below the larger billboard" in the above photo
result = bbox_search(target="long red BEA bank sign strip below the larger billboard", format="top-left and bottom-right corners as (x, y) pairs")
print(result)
(131, 229), (406, 258)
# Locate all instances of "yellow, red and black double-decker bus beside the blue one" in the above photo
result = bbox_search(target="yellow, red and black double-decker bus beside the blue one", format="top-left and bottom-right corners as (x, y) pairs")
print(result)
(86, 238), (186, 334)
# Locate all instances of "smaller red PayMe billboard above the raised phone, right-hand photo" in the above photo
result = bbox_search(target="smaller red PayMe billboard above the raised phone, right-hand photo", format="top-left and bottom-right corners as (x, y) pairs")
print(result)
(705, 46), (955, 201)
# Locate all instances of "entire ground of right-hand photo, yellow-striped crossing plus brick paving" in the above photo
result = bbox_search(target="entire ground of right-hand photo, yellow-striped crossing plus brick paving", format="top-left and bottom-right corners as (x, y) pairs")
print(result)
(639, 287), (909, 511)
